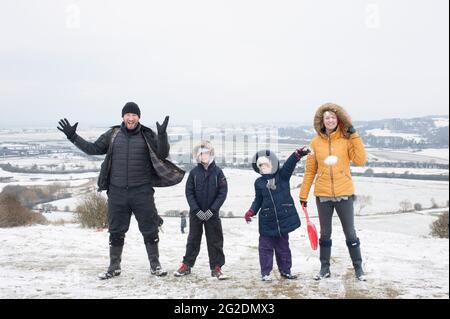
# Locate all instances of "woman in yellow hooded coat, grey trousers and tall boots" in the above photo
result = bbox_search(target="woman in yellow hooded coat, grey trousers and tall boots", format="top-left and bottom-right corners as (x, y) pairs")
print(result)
(300, 103), (366, 280)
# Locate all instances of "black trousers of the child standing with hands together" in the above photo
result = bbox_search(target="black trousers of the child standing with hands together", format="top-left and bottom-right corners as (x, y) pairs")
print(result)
(183, 214), (225, 270)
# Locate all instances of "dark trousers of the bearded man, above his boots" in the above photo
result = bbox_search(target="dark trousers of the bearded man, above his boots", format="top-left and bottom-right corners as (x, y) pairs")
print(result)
(108, 185), (158, 246)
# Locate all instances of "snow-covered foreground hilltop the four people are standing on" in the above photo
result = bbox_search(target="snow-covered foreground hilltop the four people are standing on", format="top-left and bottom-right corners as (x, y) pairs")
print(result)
(0, 213), (449, 299)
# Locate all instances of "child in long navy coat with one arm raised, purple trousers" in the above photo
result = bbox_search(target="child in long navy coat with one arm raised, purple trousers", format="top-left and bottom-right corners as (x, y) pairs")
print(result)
(245, 147), (310, 281)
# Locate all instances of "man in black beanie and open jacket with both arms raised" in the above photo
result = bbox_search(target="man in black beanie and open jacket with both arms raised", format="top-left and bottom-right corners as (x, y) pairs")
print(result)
(58, 102), (185, 279)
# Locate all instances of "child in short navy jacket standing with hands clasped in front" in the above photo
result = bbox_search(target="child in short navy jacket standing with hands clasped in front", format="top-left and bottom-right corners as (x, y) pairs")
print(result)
(174, 141), (228, 280)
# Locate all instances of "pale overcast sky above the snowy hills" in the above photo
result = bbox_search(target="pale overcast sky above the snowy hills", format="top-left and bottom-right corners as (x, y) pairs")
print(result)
(0, 0), (449, 128)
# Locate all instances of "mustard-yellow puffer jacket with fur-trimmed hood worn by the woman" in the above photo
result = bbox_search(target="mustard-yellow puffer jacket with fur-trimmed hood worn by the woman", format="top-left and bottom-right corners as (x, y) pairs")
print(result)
(300, 103), (367, 201)
